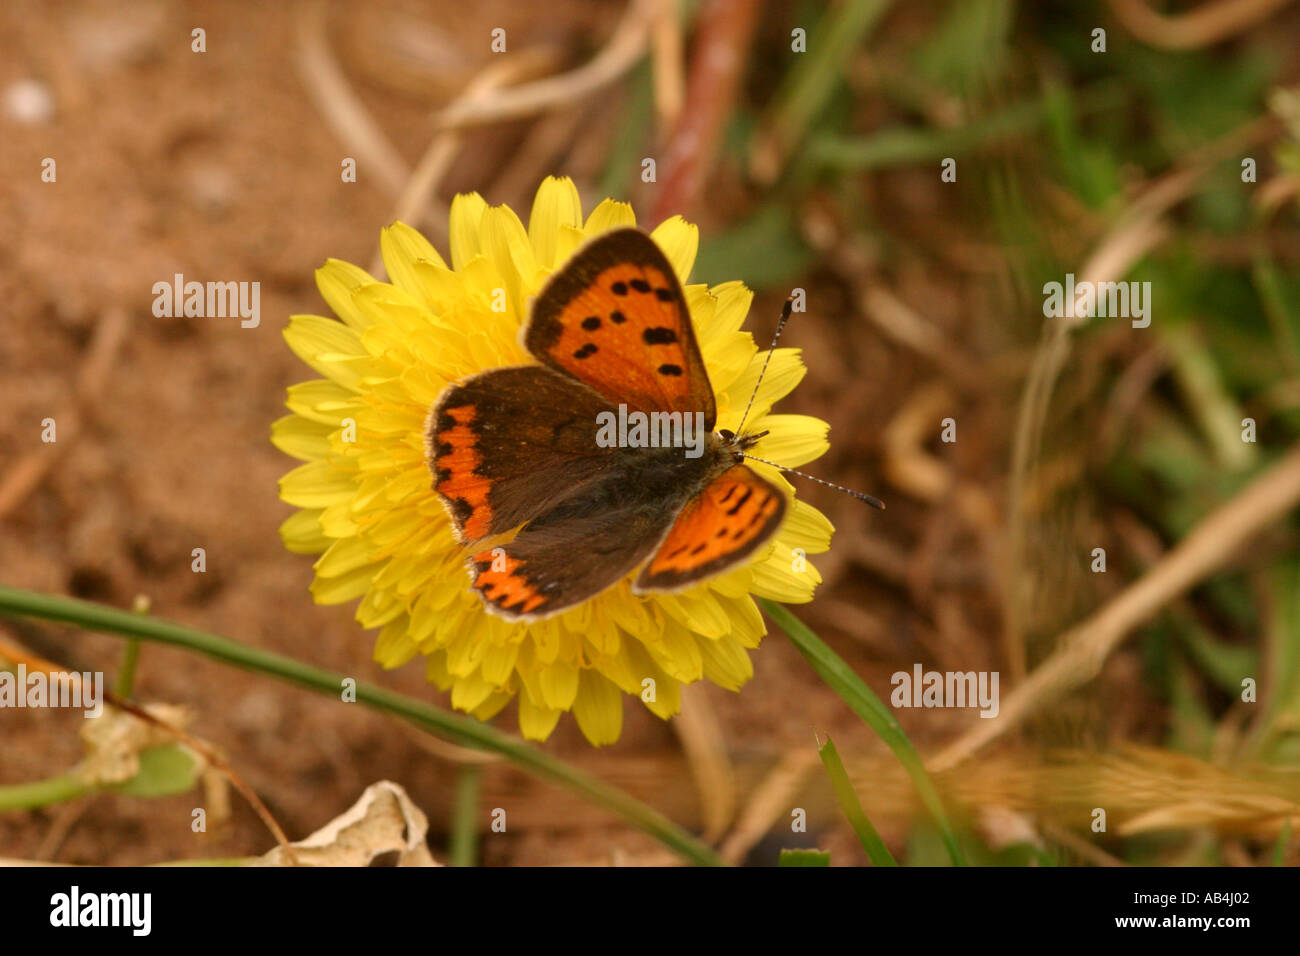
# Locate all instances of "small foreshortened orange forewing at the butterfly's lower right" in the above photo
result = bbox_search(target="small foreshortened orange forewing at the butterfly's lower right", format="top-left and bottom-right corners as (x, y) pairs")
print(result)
(633, 464), (785, 592)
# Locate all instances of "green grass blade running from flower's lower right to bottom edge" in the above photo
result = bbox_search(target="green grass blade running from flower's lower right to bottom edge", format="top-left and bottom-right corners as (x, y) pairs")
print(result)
(759, 598), (966, 866)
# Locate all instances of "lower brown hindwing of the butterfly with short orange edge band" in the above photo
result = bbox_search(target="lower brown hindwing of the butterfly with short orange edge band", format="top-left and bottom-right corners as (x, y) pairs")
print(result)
(469, 494), (673, 620)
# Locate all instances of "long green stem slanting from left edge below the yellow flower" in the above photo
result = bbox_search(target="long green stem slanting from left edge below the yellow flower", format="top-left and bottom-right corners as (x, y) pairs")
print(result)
(0, 587), (722, 866)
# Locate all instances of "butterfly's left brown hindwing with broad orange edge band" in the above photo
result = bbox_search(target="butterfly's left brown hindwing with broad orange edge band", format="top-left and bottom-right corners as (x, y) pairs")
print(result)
(428, 365), (616, 541)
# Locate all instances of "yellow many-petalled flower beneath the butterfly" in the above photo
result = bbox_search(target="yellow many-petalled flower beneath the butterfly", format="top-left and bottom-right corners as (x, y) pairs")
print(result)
(272, 178), (832, 744)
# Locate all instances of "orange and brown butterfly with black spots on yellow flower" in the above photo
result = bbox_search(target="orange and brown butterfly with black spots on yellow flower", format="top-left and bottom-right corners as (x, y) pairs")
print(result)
(426, 228), (816, 620)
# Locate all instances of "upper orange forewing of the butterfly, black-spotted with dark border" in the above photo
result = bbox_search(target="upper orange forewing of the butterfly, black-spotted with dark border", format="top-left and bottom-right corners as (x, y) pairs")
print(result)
(524, 229), (716, 431)
